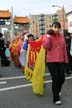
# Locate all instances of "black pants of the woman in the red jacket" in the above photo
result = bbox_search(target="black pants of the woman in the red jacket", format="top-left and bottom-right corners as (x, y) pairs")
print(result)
(47, 63), (65, 102)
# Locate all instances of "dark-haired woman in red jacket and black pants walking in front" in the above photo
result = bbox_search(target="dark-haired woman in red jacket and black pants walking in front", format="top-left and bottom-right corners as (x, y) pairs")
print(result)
(43, 22), (68, 105)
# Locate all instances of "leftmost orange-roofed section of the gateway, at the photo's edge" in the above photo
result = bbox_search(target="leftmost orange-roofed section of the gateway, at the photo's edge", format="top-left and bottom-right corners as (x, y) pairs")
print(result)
(0, 10), (11, 41)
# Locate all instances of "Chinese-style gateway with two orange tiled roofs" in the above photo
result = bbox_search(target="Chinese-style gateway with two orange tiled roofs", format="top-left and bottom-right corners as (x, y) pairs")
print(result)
(0, 10), (29, 41)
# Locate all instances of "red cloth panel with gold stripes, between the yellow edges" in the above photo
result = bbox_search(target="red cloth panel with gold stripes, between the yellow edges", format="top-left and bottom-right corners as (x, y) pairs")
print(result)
(28, 39), (42, 69)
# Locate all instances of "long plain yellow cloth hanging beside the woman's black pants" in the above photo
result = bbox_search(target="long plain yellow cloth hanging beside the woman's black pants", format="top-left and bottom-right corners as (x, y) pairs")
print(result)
(32, 47), (45, 95)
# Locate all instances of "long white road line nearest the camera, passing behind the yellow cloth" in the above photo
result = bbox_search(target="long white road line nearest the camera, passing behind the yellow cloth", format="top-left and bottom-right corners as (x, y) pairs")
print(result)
(0, 76), (72, 91)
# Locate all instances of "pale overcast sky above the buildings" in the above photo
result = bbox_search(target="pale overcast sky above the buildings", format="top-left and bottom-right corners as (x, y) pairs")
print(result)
(0, 0), (72, 16)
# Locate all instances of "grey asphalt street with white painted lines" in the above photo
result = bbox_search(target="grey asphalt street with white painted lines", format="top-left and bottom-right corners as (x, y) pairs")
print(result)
(0, 64), (72, 108)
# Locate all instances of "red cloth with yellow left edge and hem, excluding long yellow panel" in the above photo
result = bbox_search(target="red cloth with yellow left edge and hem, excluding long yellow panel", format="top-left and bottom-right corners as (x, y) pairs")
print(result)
(24, 38), (42, 81)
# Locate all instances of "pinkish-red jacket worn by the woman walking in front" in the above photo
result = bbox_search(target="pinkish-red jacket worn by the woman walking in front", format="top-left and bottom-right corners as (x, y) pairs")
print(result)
(43, 33), (68, 63)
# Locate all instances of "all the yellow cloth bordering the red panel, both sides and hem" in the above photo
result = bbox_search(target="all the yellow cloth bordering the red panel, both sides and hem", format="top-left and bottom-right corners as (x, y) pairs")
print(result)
(24, 39), (45, 95)
